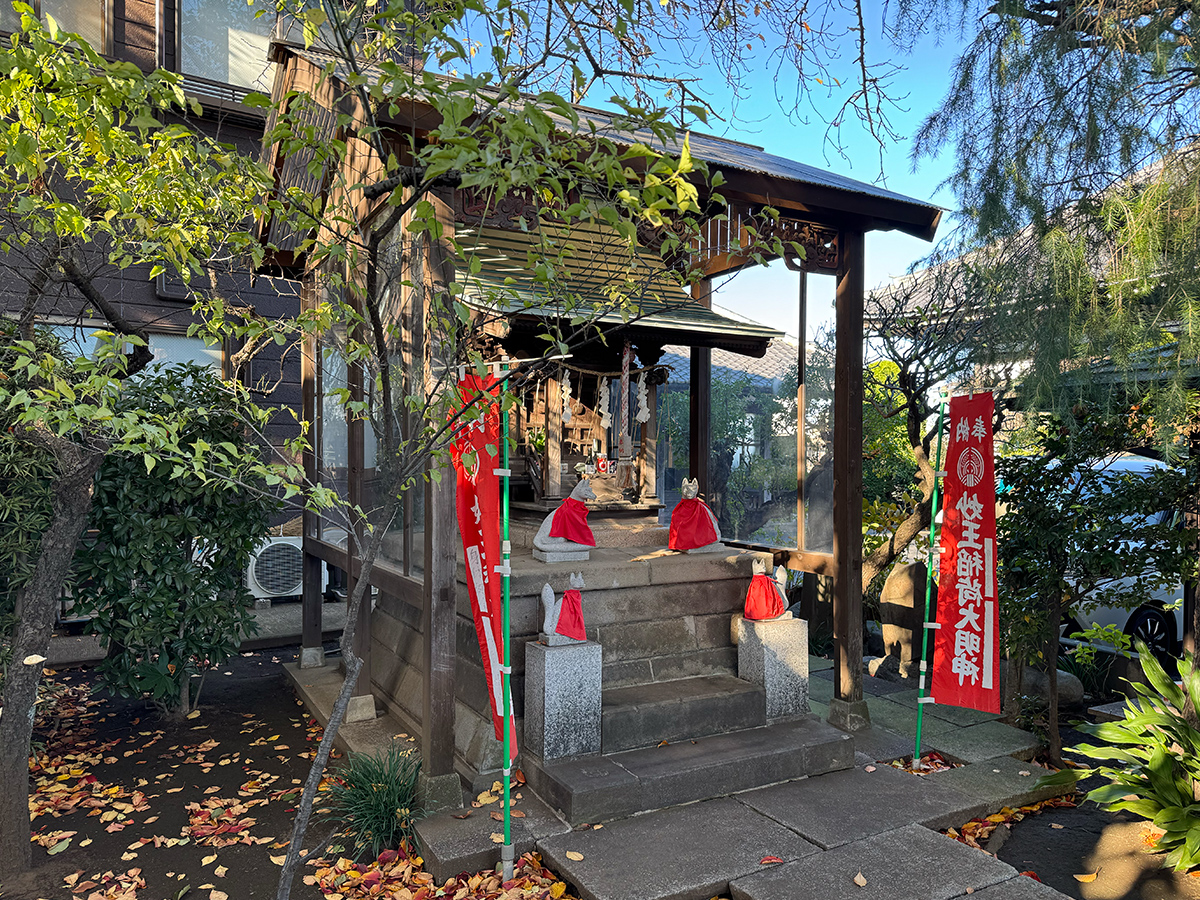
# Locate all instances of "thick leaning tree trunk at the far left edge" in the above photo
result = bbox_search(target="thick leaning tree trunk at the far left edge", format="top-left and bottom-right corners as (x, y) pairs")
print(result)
(0, 442), (104, 876)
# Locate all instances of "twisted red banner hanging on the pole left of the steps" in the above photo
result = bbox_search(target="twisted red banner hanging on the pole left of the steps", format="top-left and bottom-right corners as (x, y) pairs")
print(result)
(450, 373), (517, 757)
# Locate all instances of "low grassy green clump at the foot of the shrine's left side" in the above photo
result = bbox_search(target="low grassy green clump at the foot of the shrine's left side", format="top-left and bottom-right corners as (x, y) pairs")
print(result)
(326, 744), (422, 859)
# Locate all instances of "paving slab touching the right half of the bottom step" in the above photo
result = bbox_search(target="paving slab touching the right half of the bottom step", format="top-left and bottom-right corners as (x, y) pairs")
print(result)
(737, 766), (976, 850)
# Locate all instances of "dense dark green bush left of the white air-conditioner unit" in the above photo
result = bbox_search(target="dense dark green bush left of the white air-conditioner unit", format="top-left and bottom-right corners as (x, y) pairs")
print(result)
(77, 366), (277, 715)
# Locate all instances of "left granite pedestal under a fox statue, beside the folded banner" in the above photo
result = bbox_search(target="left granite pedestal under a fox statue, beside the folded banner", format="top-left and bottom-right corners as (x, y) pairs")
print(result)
(524, 641), (602, 760)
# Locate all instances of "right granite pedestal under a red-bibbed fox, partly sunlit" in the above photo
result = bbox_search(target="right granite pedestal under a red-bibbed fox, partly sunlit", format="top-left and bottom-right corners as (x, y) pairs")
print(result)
(733, 616), (809, 722)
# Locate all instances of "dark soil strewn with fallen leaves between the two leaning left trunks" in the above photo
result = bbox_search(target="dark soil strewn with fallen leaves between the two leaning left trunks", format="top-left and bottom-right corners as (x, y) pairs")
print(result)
(2, 652), (333, 900)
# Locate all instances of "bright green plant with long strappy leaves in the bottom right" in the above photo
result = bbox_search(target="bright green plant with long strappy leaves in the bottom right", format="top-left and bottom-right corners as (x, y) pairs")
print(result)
(1038, 641), (1200, 871)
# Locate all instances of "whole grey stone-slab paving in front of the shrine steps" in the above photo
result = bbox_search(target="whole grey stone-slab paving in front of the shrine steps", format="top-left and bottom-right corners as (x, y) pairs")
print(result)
(418, 659), (1064, 900)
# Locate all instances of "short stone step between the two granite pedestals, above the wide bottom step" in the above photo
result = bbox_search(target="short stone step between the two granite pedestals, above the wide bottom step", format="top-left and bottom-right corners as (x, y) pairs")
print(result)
(600, 674), (767, 754)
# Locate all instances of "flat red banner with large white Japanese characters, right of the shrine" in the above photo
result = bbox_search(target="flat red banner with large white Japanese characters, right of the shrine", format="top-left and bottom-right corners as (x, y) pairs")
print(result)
(930, 394), (1000, 713)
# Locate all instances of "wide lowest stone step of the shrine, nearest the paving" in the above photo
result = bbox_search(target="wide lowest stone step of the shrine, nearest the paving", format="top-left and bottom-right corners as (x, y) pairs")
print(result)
(521, 716), (854, 824)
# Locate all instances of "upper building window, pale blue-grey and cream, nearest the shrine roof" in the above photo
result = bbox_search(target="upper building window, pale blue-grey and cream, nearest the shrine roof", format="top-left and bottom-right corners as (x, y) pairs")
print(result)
(179, 0), (275, 92)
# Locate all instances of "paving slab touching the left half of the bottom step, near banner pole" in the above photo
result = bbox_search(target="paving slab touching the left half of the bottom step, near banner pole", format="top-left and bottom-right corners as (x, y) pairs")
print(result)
(538, 798), (820, 900)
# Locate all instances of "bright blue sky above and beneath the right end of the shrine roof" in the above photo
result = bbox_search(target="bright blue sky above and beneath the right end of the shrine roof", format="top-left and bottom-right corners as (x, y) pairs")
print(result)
(700, 8), (959, 336)
